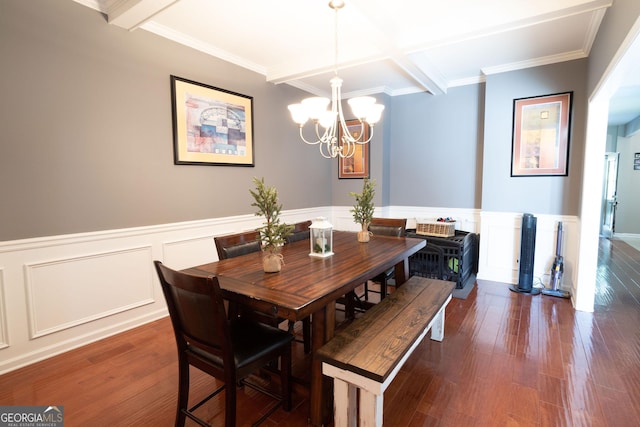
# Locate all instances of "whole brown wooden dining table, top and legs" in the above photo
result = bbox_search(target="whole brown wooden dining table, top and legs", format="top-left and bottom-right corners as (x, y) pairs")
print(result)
(183, 231), (426, 426)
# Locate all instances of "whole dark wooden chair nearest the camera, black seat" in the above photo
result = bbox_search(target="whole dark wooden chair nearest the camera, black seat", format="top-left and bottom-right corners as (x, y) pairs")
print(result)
(154, 261), (293, 427)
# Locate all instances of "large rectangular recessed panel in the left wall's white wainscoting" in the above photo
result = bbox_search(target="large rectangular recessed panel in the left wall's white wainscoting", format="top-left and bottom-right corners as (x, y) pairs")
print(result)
(25, 246), (155, 339)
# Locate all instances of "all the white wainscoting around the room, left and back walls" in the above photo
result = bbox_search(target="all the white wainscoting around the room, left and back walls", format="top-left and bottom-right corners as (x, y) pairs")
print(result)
(0, 206), (578, 374)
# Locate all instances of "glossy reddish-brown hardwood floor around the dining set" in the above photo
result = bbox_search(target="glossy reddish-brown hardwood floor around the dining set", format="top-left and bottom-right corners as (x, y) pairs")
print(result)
(0, 239), (640, 427)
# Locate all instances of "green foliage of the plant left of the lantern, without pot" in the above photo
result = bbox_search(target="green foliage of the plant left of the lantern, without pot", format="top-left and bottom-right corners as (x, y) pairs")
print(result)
(249, 177), (293, 249)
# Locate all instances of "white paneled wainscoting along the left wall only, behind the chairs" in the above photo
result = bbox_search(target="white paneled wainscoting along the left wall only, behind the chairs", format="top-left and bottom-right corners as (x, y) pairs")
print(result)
(0, 207), (324, 374)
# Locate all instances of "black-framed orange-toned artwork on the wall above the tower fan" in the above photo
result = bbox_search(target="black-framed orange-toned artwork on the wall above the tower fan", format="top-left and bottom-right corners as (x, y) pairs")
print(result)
(511, 92), (573, 176)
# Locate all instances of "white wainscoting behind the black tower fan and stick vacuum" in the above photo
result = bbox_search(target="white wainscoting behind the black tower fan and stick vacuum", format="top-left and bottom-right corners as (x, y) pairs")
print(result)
(478, 212), (580, 304)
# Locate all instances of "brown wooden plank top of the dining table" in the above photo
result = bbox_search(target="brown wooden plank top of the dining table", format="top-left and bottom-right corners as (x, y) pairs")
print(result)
(183, 231), (425, 321)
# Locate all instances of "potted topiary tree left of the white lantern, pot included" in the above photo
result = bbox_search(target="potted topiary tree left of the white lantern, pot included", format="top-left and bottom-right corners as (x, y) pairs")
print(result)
(249, 177), (293, 273)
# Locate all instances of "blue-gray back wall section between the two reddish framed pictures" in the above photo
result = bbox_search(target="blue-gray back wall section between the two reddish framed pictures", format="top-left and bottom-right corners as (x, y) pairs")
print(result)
(389, 84), (485, 209)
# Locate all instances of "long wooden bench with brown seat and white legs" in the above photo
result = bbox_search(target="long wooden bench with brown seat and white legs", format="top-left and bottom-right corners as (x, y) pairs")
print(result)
(316, 276), (455, 427)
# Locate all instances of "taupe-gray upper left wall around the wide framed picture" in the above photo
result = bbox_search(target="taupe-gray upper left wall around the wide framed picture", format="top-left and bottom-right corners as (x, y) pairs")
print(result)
(0, 0), (332, 241)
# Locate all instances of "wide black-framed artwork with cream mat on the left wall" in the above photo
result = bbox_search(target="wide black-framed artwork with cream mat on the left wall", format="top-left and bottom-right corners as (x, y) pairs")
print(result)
(171, 76), (254, 166)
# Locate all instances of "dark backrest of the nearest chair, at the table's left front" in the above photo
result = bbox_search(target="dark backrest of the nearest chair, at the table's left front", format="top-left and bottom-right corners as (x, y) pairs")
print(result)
(154, 261), (233, 365)
